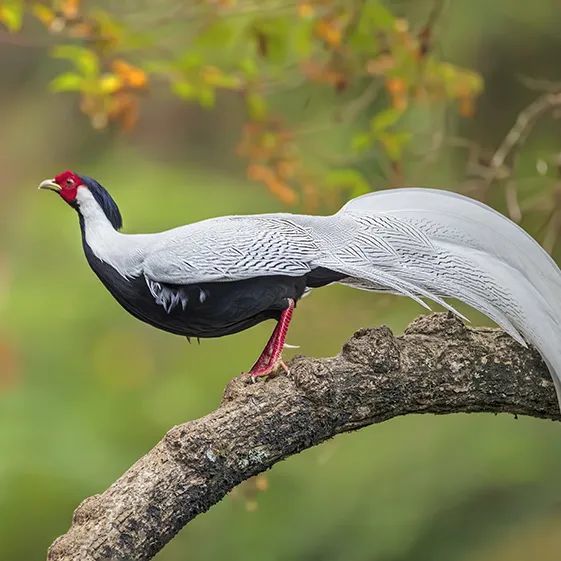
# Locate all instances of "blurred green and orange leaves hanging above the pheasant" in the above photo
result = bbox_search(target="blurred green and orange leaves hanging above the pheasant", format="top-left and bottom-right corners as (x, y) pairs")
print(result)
(0, 0), (482, 208)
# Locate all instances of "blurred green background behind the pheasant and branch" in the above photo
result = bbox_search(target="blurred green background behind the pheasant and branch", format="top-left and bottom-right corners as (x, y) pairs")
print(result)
(0, 0), (561, 561)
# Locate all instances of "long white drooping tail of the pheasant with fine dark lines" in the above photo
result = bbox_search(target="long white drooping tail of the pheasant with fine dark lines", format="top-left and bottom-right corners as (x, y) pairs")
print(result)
(317, 188), (561, 403)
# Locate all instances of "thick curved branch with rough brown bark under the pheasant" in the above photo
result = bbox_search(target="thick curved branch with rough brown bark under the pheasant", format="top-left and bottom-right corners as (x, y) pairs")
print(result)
(48, 314), (560, 561)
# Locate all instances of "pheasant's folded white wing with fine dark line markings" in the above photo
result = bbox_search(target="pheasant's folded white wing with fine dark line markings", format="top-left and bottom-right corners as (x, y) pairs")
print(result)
(143, 215), (320, 285)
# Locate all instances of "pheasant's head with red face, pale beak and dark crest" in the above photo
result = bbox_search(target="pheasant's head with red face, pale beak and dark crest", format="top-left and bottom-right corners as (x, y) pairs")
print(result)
(39, 170), (123, 230)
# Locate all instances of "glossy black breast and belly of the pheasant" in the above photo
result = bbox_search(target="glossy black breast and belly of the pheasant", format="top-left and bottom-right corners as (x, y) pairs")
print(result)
(84, 244), (343, 338)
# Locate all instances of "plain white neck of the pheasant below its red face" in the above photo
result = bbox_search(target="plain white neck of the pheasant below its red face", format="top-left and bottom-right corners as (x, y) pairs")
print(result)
(76, 187), (155, 278)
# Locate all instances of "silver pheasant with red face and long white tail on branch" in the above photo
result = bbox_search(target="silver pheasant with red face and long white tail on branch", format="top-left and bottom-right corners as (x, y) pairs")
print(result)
(39, 170), (561, 404)
